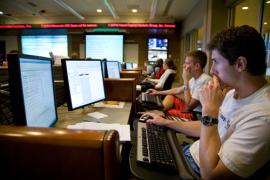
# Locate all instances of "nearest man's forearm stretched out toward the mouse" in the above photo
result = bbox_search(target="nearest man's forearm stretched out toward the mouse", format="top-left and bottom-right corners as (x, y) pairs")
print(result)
(165, 120), (201, 137)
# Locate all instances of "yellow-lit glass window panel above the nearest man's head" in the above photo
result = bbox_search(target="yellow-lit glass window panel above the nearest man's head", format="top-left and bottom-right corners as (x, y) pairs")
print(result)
(234, 0), (260, 30)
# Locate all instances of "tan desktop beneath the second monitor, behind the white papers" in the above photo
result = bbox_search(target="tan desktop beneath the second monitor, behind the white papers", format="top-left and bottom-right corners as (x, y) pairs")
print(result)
(54, 102), (132, 128)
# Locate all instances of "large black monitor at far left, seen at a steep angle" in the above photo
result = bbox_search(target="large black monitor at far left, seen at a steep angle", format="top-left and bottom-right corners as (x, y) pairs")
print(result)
(8, 54), (57, 127)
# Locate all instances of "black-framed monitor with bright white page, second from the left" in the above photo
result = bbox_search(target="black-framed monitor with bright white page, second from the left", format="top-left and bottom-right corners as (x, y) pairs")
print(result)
(62, 59), (105, 111)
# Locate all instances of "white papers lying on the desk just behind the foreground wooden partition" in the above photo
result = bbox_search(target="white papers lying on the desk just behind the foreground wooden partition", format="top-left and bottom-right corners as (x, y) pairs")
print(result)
(67, 122), (130, 142)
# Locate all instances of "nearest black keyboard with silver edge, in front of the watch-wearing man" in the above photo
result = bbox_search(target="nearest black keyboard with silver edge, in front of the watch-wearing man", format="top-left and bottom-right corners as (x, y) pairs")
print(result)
(136, 122), (177, 171)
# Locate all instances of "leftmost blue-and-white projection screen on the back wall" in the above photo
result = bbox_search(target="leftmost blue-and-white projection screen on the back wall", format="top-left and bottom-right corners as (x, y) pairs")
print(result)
(21, 35), (68, 57)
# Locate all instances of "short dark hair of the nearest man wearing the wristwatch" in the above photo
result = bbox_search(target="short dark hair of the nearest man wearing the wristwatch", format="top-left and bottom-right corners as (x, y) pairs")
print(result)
(208, 25), (266, 75)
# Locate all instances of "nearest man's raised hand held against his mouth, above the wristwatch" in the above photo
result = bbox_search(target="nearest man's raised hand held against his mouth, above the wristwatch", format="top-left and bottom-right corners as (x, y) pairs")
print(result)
(200, 76), (224, 118)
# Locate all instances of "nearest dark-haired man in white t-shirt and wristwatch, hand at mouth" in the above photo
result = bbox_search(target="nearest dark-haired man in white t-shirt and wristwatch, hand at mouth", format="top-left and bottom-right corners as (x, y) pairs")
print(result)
(146, 25), (270, 179)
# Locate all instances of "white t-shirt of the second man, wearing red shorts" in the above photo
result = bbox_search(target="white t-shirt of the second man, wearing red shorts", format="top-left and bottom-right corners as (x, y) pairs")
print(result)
(189, 73), (211, 112)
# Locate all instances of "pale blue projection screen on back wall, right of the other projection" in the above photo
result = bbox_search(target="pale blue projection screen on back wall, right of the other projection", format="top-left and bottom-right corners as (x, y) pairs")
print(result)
(85, 34), (124, 62)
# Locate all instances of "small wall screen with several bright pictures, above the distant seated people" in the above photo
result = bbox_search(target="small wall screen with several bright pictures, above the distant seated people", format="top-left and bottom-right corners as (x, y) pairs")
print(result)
(148, 38), (168, 61)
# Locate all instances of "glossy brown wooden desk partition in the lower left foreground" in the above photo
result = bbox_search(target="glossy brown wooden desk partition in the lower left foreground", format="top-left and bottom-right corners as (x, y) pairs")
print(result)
(0, 126), (120, 179)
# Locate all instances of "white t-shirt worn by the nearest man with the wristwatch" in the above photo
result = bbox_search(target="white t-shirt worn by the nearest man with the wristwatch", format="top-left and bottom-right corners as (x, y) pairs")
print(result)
(190, 85), (270, 178)
